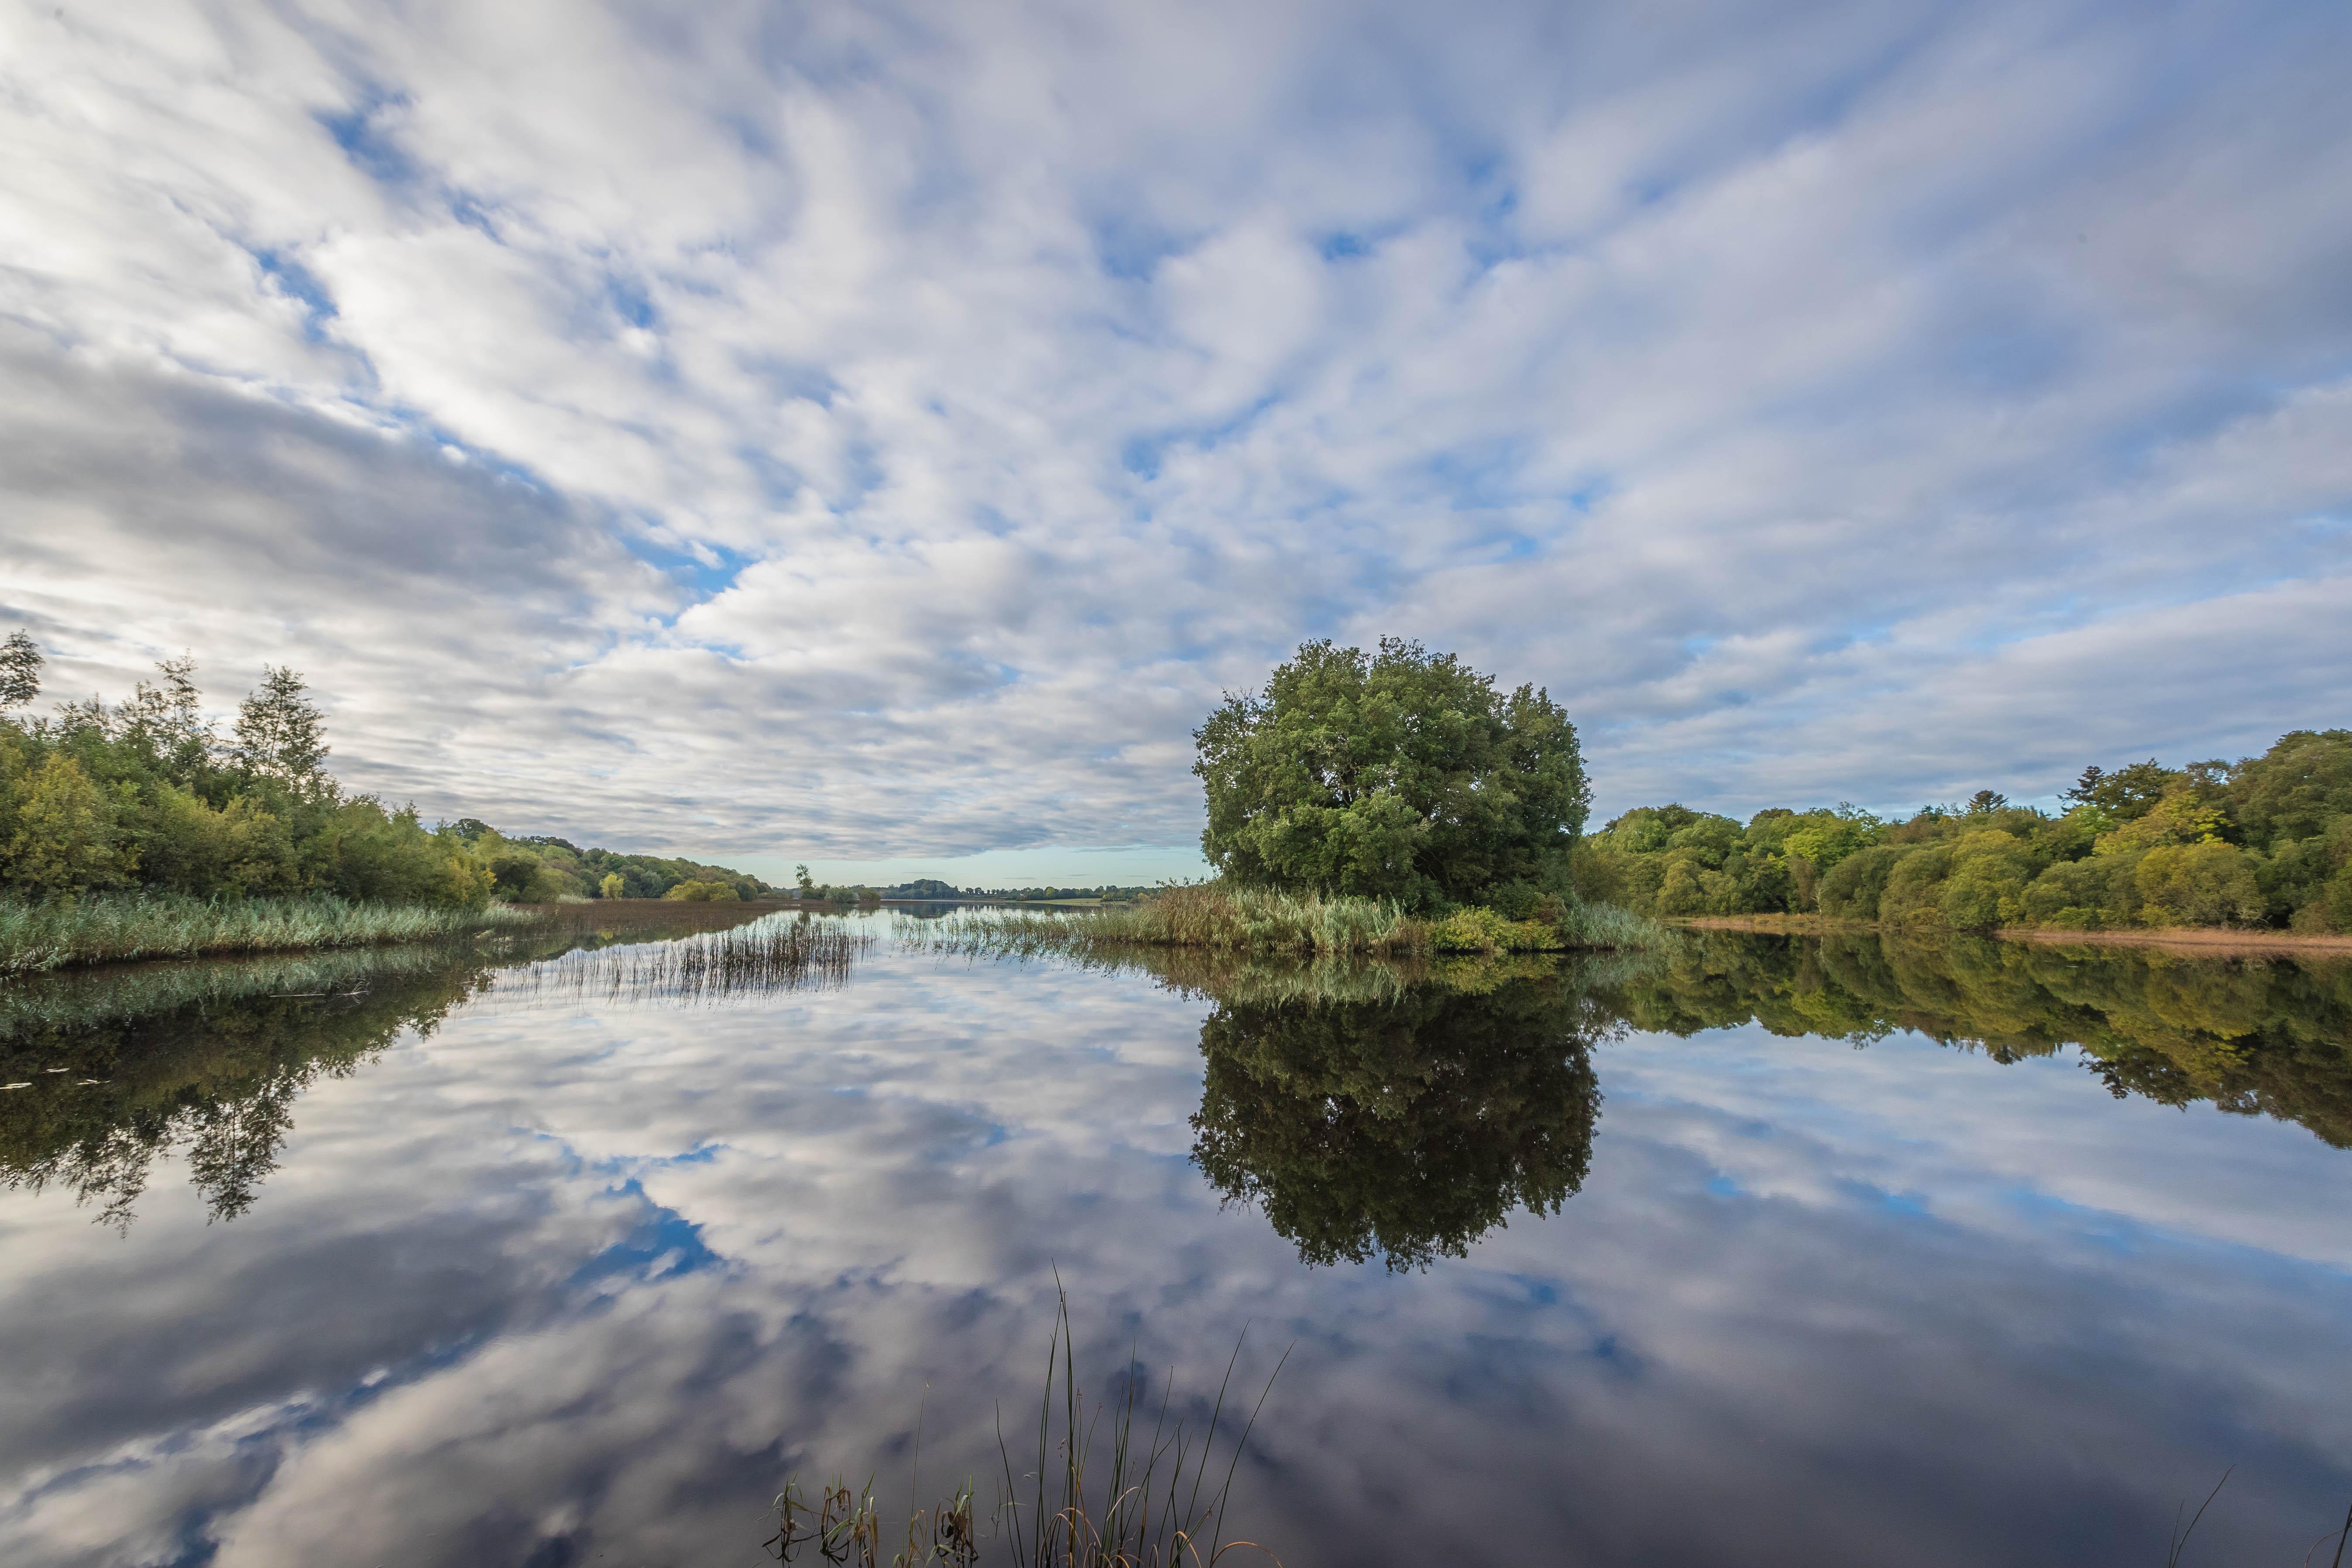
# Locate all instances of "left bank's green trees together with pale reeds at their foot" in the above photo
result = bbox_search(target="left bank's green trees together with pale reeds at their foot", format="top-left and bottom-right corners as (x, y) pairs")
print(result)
(0, 632), (772, 973)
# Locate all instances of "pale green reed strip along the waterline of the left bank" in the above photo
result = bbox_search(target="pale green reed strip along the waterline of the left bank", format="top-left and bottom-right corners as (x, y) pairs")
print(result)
(0, 893), (534, 976)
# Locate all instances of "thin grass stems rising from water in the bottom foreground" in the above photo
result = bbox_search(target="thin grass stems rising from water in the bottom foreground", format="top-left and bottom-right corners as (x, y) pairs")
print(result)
(767, 1293), (1289, 1568)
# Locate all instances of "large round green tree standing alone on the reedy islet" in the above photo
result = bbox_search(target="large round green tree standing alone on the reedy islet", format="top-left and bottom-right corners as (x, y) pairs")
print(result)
(1192, 637), (1592, 907)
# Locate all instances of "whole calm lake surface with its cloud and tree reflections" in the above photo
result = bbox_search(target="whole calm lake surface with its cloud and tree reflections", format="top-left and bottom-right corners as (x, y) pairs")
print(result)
(0, 922), (2352, 1568)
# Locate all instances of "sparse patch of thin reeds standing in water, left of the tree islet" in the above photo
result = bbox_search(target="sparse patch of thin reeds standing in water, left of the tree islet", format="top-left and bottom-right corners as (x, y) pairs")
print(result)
(498, 914), (875, 1004)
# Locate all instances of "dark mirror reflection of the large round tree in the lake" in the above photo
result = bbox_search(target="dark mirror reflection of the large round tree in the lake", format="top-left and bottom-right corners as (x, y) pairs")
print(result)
(1192, 973), (1607, 1269)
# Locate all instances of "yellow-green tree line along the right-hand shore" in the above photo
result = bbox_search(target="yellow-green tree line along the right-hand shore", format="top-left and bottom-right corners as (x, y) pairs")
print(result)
(1573, 729), (2352, 933)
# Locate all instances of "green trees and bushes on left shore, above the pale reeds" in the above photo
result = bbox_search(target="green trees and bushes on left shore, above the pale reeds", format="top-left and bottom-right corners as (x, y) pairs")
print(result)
(0, 632), (769, 907)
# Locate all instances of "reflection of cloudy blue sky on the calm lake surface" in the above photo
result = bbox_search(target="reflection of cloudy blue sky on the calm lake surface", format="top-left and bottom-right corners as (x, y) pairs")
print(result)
(0, 926), (2352, 1568)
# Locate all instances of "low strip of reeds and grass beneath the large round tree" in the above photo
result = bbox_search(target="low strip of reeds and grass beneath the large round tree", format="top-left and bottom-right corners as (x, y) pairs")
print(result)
(906, 882), (1672, 961)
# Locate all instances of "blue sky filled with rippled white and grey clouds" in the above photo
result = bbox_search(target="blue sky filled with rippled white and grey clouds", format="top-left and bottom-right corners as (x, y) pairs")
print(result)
(0, 0), (2352, 882)
